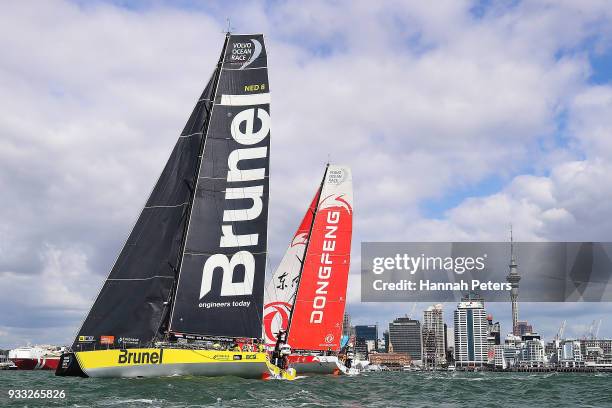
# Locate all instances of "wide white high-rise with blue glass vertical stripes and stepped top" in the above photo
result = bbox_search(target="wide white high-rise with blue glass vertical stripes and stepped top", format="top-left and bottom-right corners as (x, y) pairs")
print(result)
(454, 294), (488, 366)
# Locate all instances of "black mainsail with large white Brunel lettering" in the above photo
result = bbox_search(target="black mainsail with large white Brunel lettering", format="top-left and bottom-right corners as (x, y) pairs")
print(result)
(170, 35), (270, 338)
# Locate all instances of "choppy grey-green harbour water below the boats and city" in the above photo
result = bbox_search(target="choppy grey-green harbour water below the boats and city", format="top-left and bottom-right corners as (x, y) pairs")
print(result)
(0, 371), (612, 408)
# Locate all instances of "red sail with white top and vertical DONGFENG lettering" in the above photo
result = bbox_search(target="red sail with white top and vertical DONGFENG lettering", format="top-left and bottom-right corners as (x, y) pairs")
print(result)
(288, 165), (353, 351)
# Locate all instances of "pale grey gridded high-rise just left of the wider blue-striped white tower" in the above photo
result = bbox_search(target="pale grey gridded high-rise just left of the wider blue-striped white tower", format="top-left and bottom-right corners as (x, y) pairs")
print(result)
(422, 304), (446, 367)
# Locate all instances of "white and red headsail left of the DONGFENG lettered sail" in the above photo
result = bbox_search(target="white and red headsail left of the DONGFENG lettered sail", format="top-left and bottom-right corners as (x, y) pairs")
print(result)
(263, 189), (321, 346)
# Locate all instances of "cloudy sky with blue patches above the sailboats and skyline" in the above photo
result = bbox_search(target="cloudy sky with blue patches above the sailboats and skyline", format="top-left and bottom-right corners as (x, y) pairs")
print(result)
(0, 0), (612, 348)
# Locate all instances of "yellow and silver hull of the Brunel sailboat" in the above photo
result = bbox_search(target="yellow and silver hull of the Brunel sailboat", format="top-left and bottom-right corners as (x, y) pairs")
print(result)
(56, 348), (284, 379)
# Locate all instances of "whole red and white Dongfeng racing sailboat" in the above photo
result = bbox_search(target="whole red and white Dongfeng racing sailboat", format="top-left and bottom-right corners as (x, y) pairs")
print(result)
(263, 164), (356, 374)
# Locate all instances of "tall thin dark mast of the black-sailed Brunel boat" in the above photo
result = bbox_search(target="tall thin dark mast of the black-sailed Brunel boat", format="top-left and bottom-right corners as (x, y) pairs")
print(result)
(160, 33), (231, 335)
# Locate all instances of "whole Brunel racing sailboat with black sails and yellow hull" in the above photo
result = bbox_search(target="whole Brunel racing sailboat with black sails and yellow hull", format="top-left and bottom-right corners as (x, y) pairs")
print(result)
(56, 33), (295, 379)
